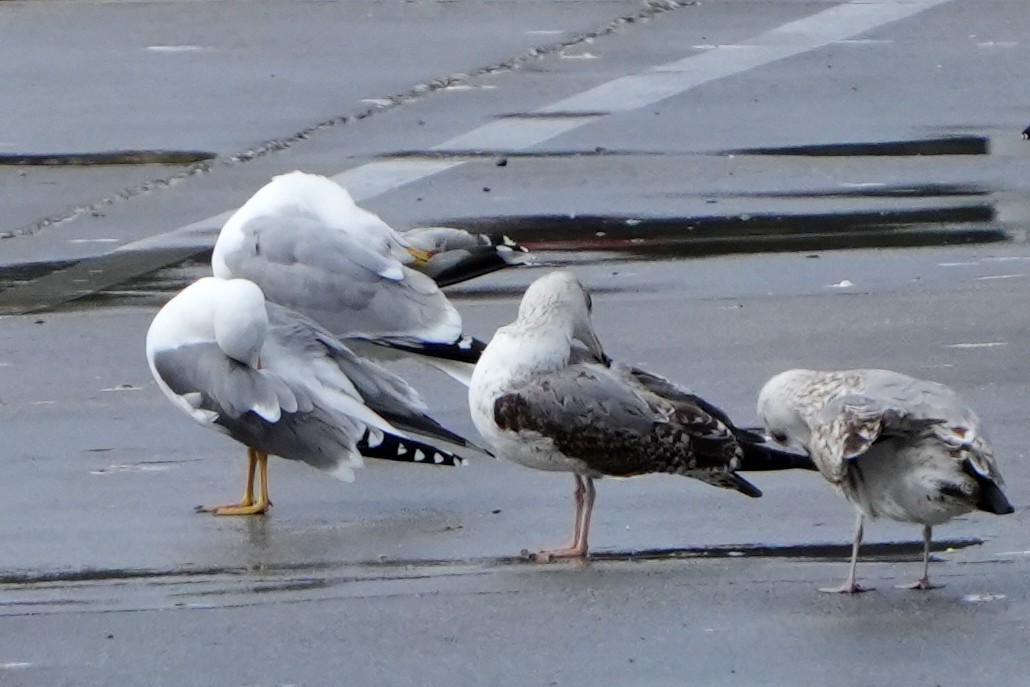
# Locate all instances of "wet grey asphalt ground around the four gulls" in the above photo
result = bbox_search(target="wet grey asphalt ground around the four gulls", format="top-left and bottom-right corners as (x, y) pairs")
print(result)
(0, 0), (1030, 687)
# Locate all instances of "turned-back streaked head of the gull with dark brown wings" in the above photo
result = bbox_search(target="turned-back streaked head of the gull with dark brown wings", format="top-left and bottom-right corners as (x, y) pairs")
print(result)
(517, 270), (608, 360)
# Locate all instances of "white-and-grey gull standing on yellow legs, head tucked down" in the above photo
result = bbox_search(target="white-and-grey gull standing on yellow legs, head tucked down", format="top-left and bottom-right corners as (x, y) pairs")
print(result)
(146, 277), (477, 515)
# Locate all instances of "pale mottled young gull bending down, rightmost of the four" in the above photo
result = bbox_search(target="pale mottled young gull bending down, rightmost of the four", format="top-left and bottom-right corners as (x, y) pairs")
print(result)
(758, 370), (1012, 593)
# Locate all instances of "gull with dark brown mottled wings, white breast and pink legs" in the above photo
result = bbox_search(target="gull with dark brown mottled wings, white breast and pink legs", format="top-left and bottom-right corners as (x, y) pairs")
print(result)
(469, 271), (808, 560)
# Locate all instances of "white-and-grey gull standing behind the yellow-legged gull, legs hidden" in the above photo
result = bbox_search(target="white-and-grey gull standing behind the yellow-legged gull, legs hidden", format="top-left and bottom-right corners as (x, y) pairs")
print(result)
(211, 172), (482, 383)
